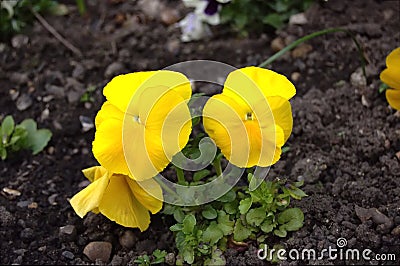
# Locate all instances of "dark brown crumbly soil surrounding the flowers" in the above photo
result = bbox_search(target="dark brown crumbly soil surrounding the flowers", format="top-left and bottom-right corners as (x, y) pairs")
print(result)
(0, 0), (400, 265)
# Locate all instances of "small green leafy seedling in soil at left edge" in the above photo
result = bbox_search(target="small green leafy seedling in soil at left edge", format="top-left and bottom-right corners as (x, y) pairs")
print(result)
(0, 115), (52, 160)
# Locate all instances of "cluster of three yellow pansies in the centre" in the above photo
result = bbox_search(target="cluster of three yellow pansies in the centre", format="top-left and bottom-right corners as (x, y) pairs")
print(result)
(70, 67), (296, 231)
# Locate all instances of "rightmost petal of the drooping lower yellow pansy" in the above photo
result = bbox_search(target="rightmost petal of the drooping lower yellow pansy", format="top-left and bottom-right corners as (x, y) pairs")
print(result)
(126, 178), (163, 214)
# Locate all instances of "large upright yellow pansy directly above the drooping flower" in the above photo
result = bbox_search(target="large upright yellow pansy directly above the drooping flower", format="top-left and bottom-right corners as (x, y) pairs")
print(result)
(93, 70), (192, 180)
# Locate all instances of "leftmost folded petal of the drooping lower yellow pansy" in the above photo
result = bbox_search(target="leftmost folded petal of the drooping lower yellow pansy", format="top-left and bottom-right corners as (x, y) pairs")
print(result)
(70, 174), (109, 218)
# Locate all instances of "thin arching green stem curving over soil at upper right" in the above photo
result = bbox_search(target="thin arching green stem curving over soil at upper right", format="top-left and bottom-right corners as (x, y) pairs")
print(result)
(259, 28), (367, 78)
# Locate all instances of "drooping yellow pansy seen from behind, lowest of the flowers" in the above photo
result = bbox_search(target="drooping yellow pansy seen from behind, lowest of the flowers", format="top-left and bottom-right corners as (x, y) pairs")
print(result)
(70, 166), (162, 231)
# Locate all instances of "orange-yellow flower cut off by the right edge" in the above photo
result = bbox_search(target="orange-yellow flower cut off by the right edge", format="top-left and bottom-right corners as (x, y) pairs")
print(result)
(380, 47), (400, 110)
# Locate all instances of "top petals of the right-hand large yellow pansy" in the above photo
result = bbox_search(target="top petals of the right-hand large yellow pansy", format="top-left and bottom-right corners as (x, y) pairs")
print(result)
(223, 66), (296, 102)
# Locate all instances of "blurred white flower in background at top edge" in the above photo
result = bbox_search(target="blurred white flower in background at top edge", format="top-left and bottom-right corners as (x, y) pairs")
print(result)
(179, 0), (231, 42)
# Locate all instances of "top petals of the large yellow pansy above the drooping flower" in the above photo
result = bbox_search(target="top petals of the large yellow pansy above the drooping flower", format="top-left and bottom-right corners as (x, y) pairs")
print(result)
(103, 70), (192, 112)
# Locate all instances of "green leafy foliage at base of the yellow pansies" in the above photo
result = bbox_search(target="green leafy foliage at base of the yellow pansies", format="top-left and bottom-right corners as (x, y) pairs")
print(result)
(163, 173), (307, 265)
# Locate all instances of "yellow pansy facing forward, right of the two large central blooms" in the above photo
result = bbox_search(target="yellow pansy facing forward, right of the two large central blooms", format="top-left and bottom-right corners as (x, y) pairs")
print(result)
(203, 67), (296, 167)
